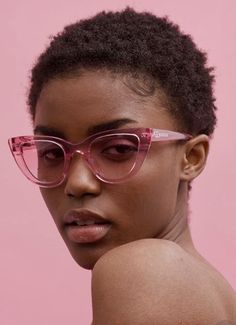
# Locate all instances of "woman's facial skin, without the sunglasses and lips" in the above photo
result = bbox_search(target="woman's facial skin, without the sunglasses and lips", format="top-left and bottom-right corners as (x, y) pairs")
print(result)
(34, 71), (186, 269)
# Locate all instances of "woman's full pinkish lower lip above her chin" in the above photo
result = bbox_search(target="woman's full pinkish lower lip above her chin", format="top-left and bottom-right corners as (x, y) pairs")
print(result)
(66, 223), (111, 243)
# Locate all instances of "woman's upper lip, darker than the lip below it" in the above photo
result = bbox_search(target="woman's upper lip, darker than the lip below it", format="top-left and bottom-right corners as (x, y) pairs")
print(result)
(63, 209), (110, 225)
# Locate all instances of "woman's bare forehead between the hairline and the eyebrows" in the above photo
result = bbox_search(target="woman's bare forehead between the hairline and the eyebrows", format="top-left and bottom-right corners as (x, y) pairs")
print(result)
(34, 72), (175, 138)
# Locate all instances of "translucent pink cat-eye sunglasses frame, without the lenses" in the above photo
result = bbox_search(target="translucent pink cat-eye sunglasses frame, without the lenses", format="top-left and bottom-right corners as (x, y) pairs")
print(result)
(8, 128), (192, 188)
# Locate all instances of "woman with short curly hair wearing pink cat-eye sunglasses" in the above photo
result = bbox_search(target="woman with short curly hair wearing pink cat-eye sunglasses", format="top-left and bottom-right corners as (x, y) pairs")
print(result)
(9, 8), (236, 325)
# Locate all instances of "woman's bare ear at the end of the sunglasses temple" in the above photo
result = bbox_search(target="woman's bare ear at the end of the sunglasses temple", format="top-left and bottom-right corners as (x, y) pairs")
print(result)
(180, 134), (209, 182)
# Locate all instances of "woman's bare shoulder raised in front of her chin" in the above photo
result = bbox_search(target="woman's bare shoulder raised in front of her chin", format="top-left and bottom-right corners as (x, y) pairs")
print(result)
(92, 239), (236, 325)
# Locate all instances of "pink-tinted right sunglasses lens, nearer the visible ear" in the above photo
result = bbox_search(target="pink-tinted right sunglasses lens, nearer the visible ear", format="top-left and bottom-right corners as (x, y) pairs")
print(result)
(90, 134), (139, 182)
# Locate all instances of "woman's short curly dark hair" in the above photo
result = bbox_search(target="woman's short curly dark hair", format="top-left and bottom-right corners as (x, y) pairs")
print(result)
(27, 7), (216, 135)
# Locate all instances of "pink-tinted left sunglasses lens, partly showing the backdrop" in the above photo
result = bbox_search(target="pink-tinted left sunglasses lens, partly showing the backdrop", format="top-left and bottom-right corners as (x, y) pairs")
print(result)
(21, 140), (65, 184)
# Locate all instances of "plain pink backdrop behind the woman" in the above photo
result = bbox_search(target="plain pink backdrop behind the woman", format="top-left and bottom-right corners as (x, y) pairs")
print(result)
(0, 0), (236, 325)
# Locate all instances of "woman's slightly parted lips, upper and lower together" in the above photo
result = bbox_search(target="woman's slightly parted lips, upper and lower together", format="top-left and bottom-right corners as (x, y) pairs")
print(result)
(64, 209), (111, 243)
